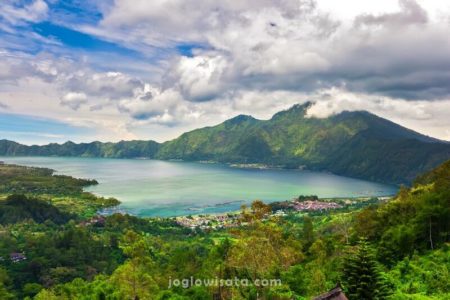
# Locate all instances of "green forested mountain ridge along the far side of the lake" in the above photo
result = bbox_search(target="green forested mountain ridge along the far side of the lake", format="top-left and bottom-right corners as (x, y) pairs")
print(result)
(0, 103), (450, 183)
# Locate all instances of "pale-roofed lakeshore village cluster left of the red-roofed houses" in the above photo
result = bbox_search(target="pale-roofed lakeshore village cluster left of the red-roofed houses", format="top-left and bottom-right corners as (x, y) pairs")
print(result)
(176, 214), (239, 230)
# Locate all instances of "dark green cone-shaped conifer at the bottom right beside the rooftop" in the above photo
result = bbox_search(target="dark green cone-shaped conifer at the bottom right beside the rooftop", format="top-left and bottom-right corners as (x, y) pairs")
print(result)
(341, 240), (389, 300)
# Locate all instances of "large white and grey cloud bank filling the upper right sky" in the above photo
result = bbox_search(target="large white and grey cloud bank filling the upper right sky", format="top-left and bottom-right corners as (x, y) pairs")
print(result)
(81, 0), (450, 101)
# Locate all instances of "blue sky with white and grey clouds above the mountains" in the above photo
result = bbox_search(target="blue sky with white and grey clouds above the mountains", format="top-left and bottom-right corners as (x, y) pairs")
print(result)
(0, 0), (450, 144)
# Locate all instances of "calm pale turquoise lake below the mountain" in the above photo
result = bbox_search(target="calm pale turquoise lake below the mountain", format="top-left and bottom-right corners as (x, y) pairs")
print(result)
(0, 157), (397, 216)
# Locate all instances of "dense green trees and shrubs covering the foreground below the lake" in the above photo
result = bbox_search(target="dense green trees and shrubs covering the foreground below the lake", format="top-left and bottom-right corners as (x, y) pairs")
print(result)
(0, 162), (450, 300)
